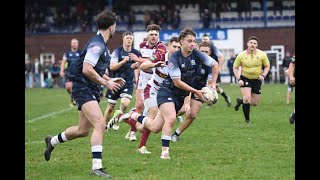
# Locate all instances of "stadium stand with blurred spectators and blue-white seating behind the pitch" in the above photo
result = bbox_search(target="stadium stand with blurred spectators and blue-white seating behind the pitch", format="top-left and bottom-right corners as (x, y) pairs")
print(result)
(25, 0), (295, 35)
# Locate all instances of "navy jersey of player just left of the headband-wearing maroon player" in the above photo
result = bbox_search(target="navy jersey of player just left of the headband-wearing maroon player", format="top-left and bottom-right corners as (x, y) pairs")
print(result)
(109, 47), (141, 84)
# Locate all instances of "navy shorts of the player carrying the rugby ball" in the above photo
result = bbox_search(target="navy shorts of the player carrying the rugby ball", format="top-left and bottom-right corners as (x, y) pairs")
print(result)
(157, 87), (185, 114)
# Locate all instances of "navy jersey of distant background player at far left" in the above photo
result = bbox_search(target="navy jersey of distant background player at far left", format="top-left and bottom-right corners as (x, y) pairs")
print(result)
(64, 49), (81, 77)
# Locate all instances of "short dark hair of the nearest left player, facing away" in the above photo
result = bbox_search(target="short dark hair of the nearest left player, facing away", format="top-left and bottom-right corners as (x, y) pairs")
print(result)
(96, 10), (117, 30)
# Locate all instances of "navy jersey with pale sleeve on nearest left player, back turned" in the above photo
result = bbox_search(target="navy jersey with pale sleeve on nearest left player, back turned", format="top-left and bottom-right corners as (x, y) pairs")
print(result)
(74, 34), (110, 92)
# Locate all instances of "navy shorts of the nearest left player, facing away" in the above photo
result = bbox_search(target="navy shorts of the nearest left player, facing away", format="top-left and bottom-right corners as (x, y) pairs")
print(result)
(72, 82), (100, 111)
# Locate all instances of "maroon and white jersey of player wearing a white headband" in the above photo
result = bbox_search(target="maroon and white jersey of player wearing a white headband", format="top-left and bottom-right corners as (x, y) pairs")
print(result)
(138, 41), (167, 89)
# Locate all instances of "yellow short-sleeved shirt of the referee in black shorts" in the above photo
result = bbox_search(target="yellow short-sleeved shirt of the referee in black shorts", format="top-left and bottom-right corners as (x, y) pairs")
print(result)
(233, 49), (270, 79)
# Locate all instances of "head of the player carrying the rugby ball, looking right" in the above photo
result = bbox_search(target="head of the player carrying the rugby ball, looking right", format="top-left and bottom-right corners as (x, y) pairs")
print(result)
(179, 27), (197, 53)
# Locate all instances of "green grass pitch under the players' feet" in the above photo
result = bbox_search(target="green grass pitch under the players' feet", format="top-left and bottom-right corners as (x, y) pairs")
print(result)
(25, 84), (295, 180)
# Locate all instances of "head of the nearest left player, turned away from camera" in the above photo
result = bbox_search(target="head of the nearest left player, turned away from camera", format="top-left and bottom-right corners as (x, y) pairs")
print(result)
(96, 10), (117, 38)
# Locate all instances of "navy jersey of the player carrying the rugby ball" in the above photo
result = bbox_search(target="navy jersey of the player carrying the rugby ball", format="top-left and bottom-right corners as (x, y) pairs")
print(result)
(160, 50), (215, 97)
